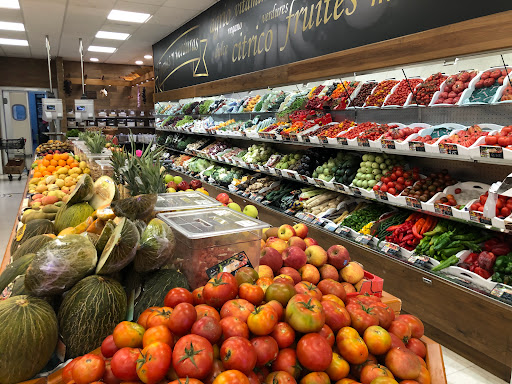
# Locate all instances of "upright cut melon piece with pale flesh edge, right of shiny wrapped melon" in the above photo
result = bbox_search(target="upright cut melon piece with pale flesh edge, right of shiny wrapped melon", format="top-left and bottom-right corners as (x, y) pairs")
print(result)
(96, 217), (140, 275)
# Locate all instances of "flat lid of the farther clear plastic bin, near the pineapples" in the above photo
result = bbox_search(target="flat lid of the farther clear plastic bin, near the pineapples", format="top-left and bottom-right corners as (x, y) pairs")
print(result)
(154, 191), (223, 212)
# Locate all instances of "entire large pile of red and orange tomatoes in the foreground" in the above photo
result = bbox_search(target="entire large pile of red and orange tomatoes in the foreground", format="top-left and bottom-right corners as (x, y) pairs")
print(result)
(62, 258), (430, 384)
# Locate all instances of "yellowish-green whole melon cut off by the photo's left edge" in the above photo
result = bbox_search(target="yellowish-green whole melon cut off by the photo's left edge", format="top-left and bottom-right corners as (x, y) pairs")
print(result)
(0, 296), (58, 384)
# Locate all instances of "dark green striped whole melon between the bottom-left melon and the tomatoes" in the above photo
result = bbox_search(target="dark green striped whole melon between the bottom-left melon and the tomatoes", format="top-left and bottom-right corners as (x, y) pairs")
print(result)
(58, 275), (127, 358)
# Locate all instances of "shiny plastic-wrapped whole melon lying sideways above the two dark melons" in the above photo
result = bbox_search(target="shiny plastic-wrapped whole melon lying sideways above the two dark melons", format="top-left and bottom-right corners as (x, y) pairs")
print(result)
(25, 235), (98, 296)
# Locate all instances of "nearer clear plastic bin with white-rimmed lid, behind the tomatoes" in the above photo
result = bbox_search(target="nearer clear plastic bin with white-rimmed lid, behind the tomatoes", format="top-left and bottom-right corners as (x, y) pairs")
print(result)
(157, 208), (269, 289)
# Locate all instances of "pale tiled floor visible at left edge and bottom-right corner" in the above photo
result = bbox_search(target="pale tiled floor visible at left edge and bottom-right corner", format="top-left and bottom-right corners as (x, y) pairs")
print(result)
(0, 175), (508, 384)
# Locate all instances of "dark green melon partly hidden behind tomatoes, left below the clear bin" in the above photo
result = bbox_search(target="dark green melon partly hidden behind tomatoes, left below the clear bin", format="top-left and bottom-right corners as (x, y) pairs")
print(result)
(133, 269), (190, 319)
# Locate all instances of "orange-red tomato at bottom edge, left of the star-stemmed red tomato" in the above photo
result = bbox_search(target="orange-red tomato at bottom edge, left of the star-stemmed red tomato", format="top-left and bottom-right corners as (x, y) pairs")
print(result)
(137, 341), (172, 384)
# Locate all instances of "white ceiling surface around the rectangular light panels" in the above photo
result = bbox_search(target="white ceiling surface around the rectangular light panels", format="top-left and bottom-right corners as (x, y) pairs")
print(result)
(0, 0), (217, 65)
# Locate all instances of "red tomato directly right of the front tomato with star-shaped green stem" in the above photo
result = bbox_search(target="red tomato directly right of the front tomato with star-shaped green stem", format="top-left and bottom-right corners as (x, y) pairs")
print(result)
(220, 336), (257, 372)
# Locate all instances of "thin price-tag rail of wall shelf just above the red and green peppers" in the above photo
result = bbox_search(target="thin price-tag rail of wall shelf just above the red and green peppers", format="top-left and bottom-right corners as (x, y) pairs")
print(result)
(165, 147), (512, 233)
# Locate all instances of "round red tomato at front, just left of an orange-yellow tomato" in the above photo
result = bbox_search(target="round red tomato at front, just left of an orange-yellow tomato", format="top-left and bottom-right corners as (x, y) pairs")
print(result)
(297, 333), (332, 371)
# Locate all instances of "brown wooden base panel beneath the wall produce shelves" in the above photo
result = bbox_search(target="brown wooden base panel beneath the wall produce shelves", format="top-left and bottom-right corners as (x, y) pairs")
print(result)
(167, 170), (512, 380)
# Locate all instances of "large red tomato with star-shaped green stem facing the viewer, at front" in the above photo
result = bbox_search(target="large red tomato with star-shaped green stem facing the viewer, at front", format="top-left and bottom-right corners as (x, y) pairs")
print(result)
(172, 335), (213, 379)
